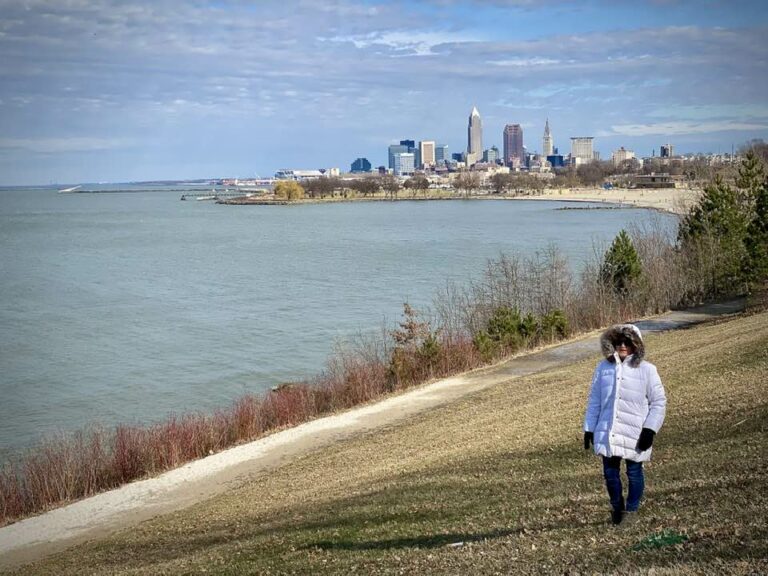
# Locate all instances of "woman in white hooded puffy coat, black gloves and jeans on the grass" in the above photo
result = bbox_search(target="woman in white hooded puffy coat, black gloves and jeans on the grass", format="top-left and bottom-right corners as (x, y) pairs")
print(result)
(584, 324), (667, 524)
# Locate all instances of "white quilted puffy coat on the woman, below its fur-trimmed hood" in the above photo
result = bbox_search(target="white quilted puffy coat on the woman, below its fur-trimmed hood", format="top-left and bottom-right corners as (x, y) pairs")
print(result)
(584, 352), (667, 462)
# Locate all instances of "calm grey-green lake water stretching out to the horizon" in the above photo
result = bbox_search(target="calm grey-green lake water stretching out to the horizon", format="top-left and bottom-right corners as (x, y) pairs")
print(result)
(0, 190), (672, 456)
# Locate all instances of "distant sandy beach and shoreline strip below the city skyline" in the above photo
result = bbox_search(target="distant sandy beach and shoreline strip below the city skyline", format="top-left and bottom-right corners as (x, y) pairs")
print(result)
(216, 187), (702, 214)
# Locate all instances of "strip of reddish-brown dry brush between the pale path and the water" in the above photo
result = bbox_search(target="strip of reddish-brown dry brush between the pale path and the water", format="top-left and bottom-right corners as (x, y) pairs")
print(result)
(0, 332), (482, 526)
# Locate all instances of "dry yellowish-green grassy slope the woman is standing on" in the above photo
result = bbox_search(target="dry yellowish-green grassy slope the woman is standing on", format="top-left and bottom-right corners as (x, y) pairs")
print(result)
(13, 313), (768, 574)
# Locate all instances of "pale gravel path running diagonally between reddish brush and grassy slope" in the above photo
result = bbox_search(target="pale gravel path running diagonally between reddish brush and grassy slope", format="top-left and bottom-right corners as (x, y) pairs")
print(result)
(0, 300), (744, 569)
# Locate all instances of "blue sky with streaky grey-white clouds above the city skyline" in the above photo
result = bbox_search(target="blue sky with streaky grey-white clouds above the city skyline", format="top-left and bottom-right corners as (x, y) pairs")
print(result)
(0, 0), (768, 185)
